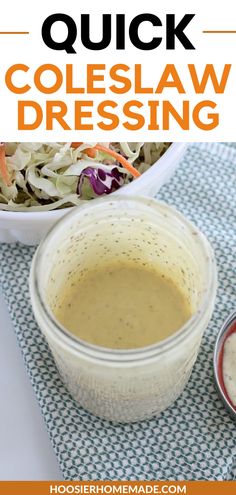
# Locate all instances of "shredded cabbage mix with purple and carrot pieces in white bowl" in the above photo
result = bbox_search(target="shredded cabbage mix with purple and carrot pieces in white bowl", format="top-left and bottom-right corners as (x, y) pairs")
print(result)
(0, 142), (170, 211)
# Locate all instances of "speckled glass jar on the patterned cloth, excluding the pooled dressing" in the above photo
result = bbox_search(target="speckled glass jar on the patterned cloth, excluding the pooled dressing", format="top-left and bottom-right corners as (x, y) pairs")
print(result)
(30, 195), (217, 422)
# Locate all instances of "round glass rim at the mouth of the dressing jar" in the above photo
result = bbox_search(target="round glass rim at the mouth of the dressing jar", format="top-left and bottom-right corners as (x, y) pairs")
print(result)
(30, 194), (217, 364)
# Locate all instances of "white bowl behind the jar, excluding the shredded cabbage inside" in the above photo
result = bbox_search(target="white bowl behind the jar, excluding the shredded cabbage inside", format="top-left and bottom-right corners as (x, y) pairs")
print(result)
(0, 143), (186, 245)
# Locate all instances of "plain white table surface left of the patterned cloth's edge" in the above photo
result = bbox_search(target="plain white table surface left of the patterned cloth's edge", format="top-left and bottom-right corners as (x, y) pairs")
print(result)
(0, 293), (63, 480)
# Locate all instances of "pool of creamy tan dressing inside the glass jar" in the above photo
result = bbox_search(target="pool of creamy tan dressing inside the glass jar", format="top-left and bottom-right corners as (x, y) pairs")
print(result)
(54, 259), (192, 349)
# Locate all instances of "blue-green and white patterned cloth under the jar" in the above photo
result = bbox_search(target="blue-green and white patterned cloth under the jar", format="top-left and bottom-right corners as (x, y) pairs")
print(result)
(0, 144), (236, 480)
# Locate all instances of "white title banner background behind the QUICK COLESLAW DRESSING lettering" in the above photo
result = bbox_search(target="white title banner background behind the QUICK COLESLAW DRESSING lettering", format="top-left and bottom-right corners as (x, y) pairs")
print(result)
(0, 0), (236, 141)
